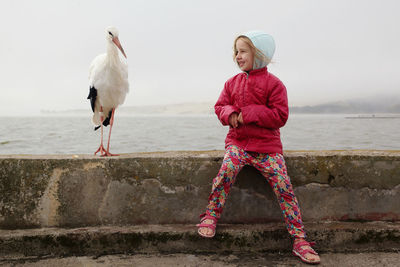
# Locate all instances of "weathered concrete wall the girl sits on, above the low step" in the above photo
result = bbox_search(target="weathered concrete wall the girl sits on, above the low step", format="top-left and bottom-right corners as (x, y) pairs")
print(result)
(0, 151), (400, 229)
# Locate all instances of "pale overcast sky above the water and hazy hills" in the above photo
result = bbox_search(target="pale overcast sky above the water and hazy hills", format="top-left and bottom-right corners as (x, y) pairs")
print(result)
(0, 0), (400, 115)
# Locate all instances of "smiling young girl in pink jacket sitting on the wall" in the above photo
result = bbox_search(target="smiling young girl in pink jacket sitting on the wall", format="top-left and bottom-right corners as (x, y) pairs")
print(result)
(197, 31), (320, 264)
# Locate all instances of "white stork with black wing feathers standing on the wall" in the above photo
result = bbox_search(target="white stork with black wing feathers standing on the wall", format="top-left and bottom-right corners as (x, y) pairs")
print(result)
(87, 26), (129, 157)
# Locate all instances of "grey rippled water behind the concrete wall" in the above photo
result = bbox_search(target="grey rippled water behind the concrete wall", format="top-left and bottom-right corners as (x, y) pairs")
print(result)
(0, 114), (400, 154)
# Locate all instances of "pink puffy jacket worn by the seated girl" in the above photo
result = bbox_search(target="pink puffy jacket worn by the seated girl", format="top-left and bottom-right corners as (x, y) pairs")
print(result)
(214, 67), (289, 154)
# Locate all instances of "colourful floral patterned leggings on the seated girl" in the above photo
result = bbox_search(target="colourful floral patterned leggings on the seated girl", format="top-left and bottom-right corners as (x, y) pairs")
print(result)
(206, 145), (306, 238)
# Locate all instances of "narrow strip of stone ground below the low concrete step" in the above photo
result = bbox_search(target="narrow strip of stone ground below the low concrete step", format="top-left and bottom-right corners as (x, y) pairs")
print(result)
(0, 252), (400, 267)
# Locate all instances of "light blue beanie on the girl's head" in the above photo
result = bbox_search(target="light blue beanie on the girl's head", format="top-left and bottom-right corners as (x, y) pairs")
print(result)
(243, 31), (275, 69)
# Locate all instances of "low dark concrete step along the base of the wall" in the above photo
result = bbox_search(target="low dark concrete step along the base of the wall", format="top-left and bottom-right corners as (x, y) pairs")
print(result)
(0, 222), (400, 258)
